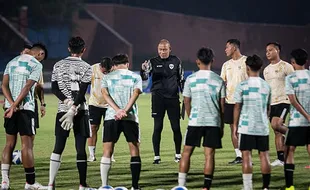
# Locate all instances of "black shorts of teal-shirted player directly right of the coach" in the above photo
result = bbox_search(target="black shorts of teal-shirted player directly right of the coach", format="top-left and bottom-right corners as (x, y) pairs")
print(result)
(184, 126), (222, 149)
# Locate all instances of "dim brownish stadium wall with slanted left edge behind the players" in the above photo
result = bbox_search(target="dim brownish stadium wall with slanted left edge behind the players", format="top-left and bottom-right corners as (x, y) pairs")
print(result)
(76, 4), (310, 69)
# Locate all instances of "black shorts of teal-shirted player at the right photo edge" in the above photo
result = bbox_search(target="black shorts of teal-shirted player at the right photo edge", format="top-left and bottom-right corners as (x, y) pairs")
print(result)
(285, 127), (310, 146)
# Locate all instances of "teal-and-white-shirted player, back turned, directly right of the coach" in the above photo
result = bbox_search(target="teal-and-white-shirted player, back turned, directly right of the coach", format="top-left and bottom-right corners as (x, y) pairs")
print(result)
(178, 48), (226, 190)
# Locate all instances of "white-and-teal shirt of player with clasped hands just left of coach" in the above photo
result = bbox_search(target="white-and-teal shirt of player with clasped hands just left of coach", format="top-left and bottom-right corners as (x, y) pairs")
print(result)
(102, 69), (142, 122)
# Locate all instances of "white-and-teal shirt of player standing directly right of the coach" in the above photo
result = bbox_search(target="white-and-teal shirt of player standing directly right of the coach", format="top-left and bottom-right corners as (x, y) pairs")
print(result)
(183, 70), (225, 126)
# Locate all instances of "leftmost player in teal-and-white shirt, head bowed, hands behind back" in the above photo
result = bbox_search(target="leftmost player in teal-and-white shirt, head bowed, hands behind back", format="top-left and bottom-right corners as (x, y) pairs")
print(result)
(1, 44), (47, 190)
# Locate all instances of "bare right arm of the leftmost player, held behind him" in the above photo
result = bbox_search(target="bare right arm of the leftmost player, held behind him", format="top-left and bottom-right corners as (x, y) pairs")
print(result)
(4, 80), (36, 118)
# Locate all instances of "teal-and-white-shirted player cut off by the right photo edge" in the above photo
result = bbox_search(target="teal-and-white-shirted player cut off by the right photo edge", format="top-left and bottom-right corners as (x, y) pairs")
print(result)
(284, 49), (310, 190)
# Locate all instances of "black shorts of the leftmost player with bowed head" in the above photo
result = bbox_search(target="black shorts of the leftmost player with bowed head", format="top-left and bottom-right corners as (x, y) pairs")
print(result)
(4, 110), (36, 136)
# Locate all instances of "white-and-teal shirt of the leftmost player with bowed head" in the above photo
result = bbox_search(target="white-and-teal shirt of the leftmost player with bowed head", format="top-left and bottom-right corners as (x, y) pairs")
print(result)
(4, 54), (42, 111)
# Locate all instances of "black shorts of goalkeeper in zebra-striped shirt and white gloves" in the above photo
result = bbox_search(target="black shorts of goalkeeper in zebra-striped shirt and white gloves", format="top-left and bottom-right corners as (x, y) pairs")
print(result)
(55, 110), (91, 138)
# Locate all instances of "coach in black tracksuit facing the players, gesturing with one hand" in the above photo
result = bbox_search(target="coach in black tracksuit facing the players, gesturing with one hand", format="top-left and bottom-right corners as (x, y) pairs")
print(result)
(140, 39), (184, 164)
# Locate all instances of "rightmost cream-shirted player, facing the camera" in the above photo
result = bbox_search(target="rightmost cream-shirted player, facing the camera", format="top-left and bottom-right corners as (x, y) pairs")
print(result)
(263, 42), (294, 166)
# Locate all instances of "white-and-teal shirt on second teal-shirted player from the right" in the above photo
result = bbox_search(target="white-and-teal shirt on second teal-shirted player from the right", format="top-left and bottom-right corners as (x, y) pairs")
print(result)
(235, 77), (271, 135)
